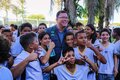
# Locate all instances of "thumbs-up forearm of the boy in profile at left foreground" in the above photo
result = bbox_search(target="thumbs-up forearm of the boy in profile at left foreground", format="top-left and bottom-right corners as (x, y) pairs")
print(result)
(11, 53), (38, 78)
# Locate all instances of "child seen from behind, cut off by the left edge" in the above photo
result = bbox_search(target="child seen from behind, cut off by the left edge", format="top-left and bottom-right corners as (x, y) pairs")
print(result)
(0, 36), (13, 80)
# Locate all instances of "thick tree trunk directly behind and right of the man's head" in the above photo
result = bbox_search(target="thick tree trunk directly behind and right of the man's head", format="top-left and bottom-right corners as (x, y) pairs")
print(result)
(64, 0), (77, 24)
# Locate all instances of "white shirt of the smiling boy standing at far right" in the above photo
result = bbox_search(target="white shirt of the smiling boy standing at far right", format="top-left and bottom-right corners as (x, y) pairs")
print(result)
(98, 43), (117, 74)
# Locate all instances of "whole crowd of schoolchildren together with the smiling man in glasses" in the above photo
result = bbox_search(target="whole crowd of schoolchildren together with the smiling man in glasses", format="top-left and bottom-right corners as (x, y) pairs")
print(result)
(0, 11), (120, 80)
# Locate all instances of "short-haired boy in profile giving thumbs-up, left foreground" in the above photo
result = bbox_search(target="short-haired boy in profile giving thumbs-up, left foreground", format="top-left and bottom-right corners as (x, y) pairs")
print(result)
(11, 32), (43, 80)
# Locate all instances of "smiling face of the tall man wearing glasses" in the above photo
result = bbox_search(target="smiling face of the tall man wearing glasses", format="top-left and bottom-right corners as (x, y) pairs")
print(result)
(56, 13), (69, 28)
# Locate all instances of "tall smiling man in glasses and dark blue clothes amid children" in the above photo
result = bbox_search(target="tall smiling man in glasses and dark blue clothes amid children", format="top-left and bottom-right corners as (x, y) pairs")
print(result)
(46, 11), (69, 64)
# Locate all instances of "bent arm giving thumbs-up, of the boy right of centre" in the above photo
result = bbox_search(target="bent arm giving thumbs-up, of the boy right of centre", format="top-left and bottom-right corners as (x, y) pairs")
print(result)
(87, 42), (107, 64)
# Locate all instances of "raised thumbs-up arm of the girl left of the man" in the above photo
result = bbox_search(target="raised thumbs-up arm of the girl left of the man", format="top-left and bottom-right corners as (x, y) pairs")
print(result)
(40, 42), (55, 64)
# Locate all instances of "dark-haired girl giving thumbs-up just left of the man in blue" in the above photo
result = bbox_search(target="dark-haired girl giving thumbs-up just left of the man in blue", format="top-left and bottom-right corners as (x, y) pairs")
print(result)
(38, 32), (55, 80)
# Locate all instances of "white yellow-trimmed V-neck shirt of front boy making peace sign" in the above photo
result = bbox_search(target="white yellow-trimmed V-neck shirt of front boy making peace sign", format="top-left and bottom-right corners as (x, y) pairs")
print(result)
(54, 64), (88, 80)
